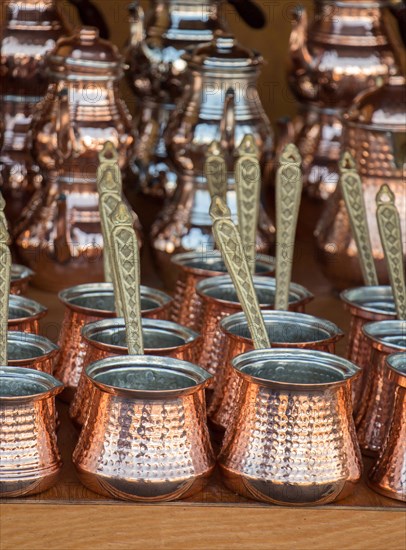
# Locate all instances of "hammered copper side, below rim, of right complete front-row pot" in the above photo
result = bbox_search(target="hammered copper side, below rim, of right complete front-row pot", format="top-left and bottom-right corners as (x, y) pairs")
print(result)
(219, 381), (361, 504)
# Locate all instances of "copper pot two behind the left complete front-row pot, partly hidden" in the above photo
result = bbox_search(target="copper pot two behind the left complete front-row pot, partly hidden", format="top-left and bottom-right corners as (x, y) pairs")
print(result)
(55, 283), (171, 401)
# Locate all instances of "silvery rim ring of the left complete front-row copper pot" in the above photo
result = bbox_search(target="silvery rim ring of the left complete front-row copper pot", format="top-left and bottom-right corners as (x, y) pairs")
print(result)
(85, 355), (212, 401)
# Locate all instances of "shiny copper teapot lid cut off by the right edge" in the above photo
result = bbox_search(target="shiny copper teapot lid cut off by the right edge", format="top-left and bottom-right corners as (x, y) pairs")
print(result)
(344, 75), (406, 132)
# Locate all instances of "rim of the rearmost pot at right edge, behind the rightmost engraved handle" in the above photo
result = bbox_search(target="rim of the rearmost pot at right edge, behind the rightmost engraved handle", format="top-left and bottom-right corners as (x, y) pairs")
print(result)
(340, 285), (396, 320)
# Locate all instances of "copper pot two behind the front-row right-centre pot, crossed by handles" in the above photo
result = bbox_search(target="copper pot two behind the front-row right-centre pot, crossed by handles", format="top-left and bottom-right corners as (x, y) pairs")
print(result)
(196, 275), (313, 388)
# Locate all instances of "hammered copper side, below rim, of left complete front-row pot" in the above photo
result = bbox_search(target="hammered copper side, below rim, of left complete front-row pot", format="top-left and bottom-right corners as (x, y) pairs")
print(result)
(73, 389), (214, 501)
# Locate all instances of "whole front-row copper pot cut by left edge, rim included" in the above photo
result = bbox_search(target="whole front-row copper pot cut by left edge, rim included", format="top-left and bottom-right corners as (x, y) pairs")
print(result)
(0, 367), (62, 498)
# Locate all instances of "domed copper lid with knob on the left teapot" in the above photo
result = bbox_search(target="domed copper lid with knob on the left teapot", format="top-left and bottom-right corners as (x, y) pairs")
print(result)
(47, 27), (123, 81)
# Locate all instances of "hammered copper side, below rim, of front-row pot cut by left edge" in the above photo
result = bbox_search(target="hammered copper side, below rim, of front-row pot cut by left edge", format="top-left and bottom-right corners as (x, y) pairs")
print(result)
(0, 397), (62, 496)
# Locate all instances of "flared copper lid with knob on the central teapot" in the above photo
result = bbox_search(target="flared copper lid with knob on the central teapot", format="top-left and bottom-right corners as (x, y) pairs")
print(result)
(183, 31), (263, 70)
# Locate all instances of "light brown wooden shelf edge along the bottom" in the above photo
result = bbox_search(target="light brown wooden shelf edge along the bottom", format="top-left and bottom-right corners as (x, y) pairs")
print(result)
(0, 503), (406, 550)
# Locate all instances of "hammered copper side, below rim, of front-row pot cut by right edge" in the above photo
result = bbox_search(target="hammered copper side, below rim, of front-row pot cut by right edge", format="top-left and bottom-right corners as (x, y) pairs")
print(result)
(369, 386), (406, 502)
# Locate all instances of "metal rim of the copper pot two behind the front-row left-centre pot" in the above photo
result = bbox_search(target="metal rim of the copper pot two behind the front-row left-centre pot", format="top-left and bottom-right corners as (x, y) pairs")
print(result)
(58, 283), (172, 318)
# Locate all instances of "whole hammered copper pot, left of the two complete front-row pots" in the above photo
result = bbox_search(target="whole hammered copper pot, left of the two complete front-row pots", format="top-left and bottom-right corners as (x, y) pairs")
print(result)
(73, 355), (215, 502)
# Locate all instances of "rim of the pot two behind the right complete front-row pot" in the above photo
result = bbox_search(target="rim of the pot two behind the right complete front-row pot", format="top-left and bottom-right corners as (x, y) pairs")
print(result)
(196, 275), (314, 307)
